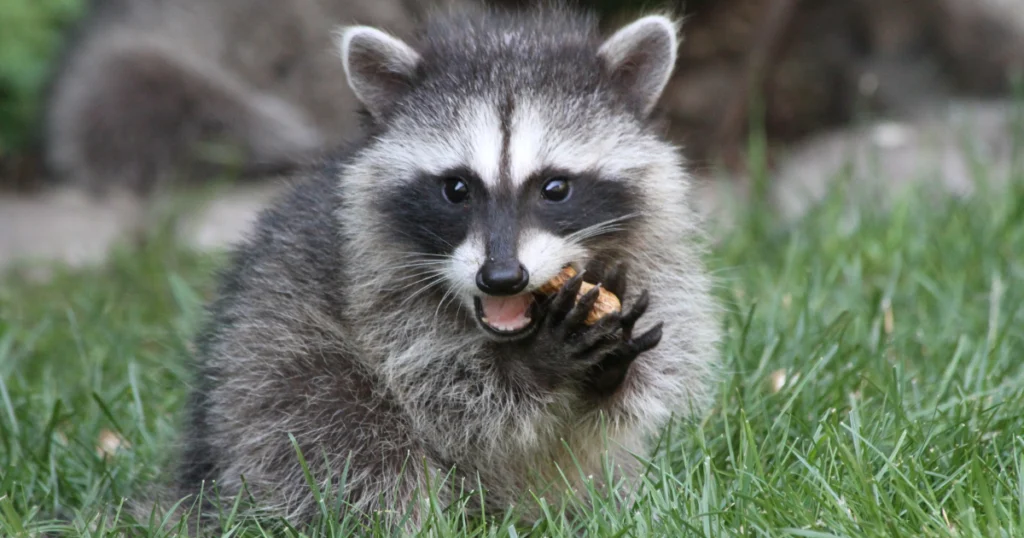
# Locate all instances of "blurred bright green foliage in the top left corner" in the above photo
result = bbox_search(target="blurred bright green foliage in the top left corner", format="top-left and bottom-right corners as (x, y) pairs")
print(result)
(0, 0), (84, 157)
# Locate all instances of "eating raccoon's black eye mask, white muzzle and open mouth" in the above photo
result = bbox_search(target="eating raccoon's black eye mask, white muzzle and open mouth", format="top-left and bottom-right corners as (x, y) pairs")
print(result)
(379, 160), (638, 339)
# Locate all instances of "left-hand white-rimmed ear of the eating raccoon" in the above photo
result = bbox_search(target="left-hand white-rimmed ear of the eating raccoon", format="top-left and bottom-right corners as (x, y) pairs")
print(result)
(335, 26), (420, 119)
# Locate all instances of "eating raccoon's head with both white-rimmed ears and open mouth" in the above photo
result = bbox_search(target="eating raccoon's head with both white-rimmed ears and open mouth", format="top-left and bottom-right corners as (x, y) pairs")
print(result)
(339, 11), (676, 341)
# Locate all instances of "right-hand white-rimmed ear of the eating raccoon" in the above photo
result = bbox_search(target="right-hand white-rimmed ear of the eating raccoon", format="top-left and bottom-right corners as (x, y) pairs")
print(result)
(598, 15), (679, 115)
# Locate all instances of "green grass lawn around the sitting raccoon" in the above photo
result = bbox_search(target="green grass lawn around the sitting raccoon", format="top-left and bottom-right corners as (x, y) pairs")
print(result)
(0, 167), (1024, 537)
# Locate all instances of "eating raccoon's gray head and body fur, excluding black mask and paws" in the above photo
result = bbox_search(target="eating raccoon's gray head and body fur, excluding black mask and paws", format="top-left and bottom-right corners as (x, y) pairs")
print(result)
(155, 5), (719, 528)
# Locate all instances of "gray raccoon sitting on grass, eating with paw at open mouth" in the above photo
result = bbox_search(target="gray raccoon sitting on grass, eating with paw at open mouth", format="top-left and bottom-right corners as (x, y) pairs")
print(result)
(157, 7), (720, 528)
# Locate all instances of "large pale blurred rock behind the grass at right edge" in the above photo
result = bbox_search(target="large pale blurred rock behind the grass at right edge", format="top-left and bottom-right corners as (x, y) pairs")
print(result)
(770, 101), (1024, 220)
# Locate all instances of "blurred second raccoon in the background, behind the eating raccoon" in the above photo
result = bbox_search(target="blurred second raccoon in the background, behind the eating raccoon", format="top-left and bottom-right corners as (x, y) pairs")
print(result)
(44, 0), (464, 195)
